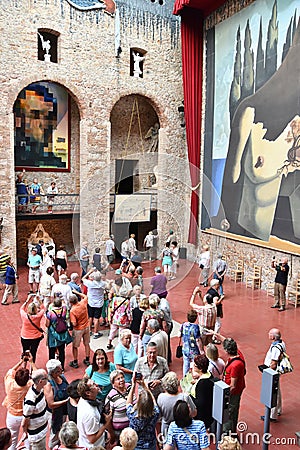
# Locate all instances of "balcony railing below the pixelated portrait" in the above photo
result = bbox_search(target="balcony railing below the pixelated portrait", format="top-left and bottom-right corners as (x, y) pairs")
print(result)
(16, 194), (80, 215)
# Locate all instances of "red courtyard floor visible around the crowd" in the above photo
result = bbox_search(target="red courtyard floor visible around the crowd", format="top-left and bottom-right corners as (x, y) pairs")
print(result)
(0, 260), (300, 449)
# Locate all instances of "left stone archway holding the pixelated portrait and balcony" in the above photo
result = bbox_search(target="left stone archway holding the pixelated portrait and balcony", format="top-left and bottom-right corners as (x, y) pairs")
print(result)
(12, 81), (80, 264)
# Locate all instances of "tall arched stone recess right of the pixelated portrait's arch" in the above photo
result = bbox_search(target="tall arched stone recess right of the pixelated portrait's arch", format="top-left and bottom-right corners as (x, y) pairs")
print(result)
(110, 94), (160, 250)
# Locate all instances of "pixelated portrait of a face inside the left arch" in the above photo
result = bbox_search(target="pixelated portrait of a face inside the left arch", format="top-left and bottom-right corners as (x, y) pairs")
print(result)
(14, 82), (69, 171)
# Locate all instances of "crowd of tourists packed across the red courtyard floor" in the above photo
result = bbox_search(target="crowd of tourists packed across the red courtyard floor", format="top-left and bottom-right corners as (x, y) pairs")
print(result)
(0, 236), (288, 450)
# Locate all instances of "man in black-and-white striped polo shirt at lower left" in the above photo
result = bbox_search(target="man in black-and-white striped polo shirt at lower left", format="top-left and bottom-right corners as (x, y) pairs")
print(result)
(22, 369), (50, 450)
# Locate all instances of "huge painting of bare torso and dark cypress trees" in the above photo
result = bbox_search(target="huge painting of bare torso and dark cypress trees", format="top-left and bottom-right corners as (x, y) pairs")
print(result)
(201, 0), (300, 244)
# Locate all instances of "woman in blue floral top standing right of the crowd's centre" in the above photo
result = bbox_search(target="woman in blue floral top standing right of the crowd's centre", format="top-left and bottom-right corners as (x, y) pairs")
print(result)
(180, 309), (200, 376)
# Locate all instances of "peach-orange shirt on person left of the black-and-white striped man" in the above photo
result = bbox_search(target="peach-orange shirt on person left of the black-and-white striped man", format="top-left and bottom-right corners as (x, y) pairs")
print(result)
(2, 369), (33, 416)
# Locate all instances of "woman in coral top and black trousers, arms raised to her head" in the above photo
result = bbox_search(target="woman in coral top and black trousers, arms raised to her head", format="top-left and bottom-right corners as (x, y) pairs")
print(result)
(20, 295), (44, 362)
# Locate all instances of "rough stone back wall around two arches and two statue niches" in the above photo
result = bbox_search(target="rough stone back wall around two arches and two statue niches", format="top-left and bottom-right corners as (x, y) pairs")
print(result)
(0, 0), (188, 264)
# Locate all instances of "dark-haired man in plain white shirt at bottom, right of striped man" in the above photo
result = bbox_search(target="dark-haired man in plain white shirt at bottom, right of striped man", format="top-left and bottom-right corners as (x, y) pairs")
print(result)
(77, 379), (112, 450)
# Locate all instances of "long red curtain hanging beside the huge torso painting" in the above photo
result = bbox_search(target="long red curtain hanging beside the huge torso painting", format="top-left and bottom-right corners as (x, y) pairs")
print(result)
(174, 7), (203, 244)
